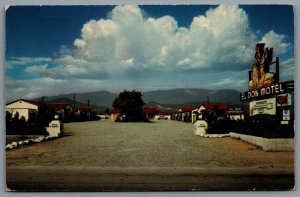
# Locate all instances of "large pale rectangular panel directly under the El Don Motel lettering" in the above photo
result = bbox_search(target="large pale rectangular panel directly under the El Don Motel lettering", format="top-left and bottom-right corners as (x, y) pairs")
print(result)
(249, 98), (276, 116)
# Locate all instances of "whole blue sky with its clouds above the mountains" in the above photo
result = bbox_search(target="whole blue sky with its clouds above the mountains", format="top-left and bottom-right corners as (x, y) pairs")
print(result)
(5, 4), (295, 101)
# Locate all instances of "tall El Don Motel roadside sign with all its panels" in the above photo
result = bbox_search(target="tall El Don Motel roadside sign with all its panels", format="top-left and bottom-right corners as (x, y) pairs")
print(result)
(240, 43), (294, 129)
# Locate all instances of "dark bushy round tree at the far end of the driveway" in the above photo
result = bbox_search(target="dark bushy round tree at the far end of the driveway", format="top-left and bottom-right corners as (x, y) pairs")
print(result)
(113, 90), (147, 122)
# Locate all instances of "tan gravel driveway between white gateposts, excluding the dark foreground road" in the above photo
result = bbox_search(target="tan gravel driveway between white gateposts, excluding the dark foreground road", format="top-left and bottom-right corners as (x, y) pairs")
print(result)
(6, 120), (294, 167)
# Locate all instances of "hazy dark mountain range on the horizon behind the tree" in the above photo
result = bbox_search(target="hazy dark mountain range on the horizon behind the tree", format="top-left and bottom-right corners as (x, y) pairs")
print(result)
(35, 88), (240, 109)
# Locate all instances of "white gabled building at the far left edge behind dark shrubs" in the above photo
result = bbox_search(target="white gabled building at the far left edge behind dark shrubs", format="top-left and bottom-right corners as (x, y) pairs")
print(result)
(5, 98), (40, 122)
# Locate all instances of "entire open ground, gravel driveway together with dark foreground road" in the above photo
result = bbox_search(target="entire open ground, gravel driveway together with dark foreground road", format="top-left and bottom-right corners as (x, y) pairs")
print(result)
(6, 120), (294, 191)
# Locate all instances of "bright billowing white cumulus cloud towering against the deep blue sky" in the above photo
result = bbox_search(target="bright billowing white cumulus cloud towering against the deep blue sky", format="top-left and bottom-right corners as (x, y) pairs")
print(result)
(69, 5), (255, 71)
